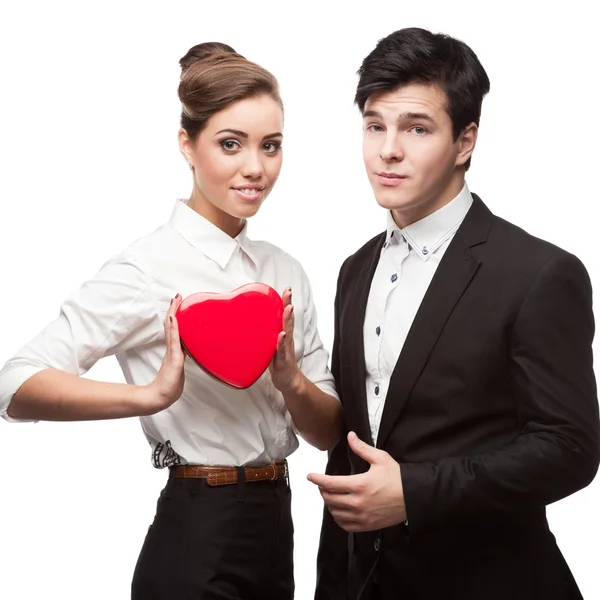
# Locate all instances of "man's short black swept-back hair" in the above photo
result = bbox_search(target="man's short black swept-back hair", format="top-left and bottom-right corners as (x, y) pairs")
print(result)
(354, 27), (490, 169)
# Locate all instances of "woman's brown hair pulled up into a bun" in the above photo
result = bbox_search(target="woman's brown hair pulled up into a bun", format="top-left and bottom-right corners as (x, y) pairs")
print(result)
(179, 42), (283, 140)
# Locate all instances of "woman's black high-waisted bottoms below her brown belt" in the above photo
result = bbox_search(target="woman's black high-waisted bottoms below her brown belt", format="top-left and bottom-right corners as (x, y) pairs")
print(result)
(131, 470), (294, 600)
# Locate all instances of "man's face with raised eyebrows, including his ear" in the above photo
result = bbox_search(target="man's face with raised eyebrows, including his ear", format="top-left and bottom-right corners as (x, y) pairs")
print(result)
(363, 83), (477, 227)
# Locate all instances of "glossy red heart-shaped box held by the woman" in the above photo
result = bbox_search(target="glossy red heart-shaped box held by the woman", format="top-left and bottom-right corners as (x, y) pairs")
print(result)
(176, 283), (283, 389)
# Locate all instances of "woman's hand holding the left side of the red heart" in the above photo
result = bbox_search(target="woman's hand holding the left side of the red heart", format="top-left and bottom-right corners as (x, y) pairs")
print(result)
(143, 294), (185, 415)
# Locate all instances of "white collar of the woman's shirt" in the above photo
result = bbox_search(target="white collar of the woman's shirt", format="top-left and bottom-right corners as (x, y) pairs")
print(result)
(169, 200), (256, 269)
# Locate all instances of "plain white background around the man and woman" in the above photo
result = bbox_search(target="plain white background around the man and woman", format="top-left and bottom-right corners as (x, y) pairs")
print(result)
(0, 0), (600, 600)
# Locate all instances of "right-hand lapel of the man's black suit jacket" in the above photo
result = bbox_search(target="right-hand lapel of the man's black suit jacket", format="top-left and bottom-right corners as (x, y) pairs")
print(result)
(376, 194), (492, 448)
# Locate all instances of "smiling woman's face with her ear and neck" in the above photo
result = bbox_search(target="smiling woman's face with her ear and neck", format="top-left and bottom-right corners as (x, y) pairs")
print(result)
(179, 95), (283, 237)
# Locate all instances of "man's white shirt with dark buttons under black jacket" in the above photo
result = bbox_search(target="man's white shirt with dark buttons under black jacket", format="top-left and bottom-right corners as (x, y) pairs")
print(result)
(363, 184), (473, 443)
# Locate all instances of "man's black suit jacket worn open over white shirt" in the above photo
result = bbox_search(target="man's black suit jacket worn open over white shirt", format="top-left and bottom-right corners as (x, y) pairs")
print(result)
(315, 196), (600, 600)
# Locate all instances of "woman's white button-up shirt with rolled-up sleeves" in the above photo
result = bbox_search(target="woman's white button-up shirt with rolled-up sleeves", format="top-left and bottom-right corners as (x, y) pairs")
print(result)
(0, 201), (337, 468)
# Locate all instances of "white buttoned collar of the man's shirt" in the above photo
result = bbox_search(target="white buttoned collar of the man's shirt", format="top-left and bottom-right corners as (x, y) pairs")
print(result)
(385, 183), (473, 260)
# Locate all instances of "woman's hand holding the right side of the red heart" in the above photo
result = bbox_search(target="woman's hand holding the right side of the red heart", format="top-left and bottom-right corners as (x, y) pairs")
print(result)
(269, 288), (303, 394)
